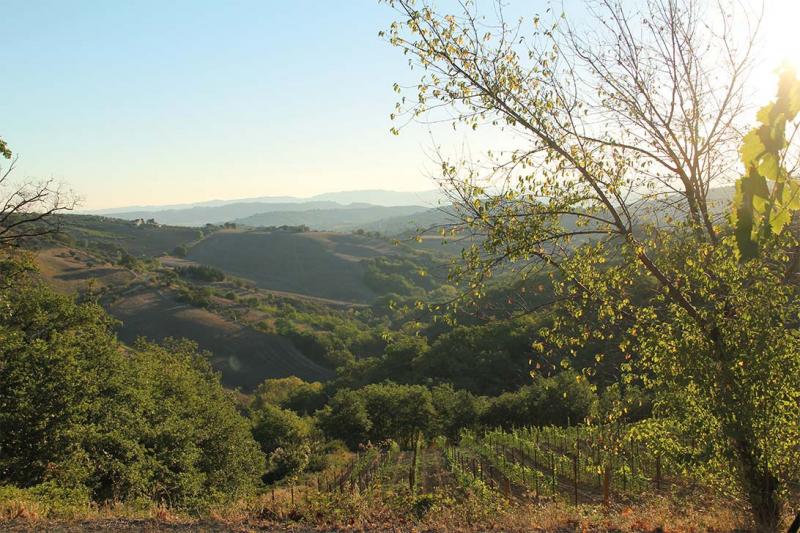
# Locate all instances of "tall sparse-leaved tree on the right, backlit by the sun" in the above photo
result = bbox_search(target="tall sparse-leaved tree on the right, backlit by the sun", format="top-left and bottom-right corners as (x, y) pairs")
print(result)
(386, 0), (800, 531)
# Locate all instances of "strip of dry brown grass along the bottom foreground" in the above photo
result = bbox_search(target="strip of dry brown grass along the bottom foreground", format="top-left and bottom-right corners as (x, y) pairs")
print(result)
(0, 489), (746, 533)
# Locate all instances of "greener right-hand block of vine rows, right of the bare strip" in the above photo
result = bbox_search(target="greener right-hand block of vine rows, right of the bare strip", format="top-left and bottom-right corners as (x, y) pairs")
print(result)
(446, 426), (674, 505)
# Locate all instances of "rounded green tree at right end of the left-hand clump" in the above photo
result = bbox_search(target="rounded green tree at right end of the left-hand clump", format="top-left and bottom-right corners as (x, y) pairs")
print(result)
(128, 339), (264, 503)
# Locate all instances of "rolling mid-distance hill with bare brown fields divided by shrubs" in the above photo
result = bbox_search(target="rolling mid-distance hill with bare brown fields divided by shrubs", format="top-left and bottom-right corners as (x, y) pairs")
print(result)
(28, 215), (454, 391)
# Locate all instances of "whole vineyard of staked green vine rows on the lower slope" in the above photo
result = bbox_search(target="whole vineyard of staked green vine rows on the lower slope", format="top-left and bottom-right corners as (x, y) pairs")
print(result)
(260, 426), (680, 511)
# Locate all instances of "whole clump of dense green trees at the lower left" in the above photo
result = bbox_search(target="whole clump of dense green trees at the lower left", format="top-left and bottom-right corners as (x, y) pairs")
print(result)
(0, 258), (264, 508)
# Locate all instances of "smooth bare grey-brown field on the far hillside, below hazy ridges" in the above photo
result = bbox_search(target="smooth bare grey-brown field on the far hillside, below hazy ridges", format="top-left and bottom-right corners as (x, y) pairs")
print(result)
(184, 231), (399, 303)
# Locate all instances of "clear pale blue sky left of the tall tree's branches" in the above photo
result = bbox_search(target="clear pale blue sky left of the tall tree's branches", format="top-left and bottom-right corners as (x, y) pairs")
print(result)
(0, 0), (433, 208)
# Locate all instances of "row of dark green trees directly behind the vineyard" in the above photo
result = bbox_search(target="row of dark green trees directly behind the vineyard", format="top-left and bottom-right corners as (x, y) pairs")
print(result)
(250, 371), (608, 449)
